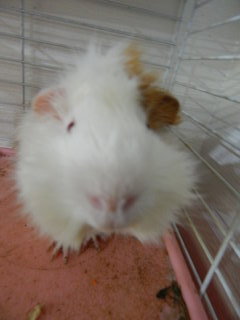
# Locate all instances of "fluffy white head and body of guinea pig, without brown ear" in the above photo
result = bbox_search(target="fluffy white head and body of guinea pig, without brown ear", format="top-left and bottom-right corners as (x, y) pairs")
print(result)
(16, 44), (195, 255)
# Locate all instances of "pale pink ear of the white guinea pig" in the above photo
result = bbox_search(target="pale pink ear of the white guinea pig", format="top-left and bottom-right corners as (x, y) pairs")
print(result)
(32, 88), (65, 120)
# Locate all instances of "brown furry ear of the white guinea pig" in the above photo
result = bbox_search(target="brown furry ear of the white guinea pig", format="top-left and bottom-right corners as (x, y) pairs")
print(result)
(142, 87), (181, 130)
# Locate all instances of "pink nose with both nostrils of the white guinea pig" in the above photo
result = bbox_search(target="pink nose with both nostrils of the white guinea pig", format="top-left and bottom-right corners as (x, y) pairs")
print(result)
(89, 195), (136, 212)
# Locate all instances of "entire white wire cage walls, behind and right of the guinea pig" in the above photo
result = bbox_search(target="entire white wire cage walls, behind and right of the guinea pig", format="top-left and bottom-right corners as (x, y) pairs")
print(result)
(0, 0), (240, 319)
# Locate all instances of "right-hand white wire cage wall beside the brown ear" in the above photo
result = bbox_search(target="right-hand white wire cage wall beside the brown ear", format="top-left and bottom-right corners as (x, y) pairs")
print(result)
(171, 1), (240, 319)
